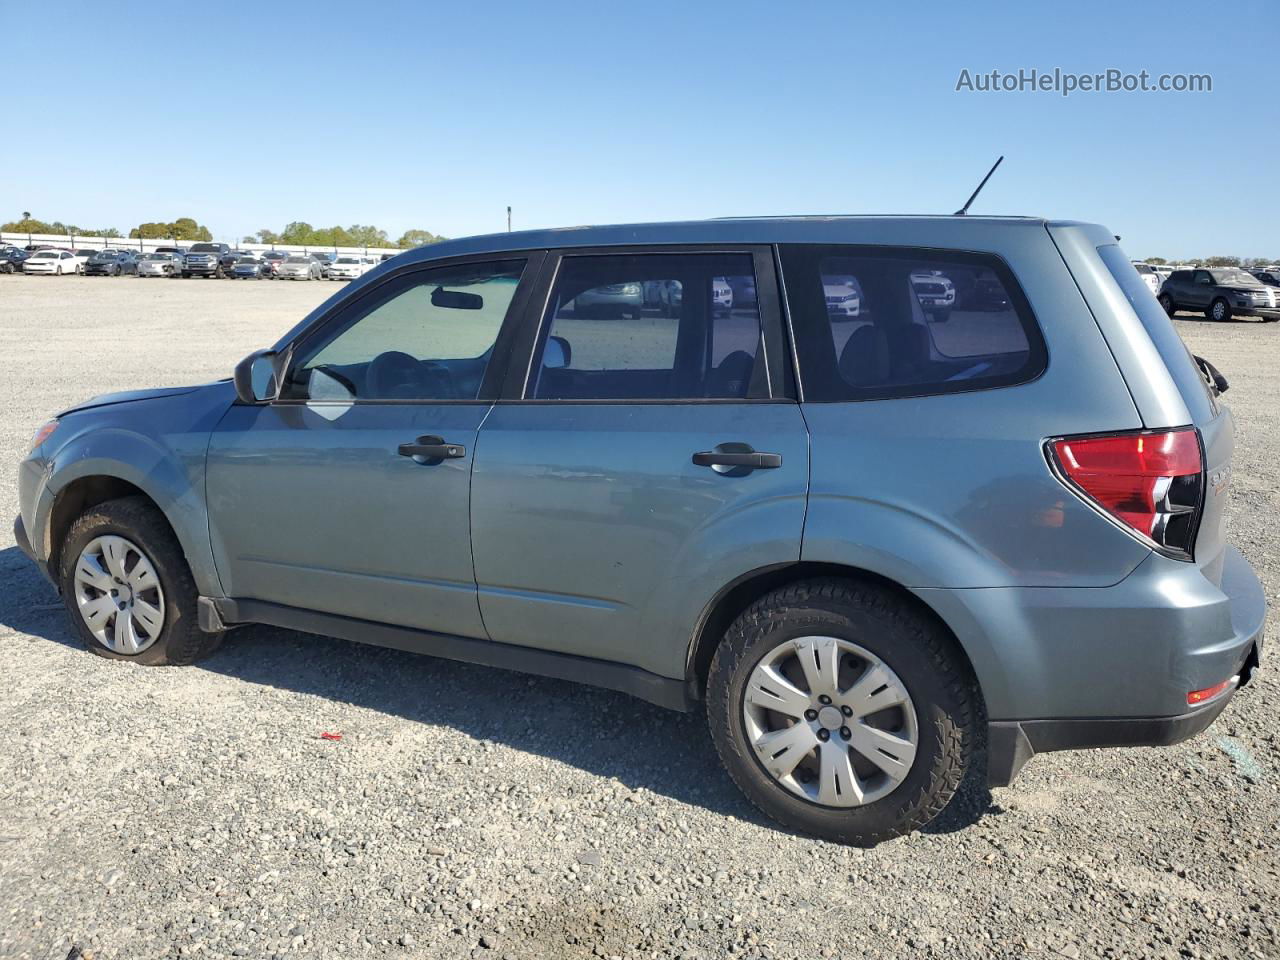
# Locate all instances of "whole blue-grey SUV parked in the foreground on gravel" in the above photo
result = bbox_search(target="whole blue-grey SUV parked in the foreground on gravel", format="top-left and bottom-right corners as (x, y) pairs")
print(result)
(15, 216), (1266, 845)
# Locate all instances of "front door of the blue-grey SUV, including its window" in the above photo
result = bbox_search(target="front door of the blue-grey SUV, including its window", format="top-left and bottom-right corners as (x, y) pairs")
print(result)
(207, 259), (532, 637)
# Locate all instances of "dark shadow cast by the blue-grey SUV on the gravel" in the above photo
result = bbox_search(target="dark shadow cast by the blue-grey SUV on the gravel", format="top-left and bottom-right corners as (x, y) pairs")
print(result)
(0, 548), (998, 833)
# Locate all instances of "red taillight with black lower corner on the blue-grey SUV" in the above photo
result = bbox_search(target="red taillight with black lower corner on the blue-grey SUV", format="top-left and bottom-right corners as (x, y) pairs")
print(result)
(1051, 428), (1204, 559)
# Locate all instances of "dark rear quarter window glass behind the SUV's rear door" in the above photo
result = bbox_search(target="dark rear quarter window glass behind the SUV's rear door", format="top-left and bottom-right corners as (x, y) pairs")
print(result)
(782, 246), (1047, 401)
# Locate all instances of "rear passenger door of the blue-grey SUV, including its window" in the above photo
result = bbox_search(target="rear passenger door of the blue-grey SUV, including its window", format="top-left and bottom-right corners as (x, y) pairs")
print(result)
(471, 247), (809, 677)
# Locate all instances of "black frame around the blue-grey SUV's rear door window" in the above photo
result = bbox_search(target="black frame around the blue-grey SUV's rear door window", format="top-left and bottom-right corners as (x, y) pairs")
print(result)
(495, 243), (795, 404)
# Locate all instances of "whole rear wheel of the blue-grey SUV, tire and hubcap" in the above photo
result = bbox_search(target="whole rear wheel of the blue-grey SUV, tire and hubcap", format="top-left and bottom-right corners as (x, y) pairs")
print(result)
(707, 580), (978, 846)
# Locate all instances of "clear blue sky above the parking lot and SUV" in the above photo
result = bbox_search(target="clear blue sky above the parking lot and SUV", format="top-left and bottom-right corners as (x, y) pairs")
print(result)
(10, 0), (1280, 257)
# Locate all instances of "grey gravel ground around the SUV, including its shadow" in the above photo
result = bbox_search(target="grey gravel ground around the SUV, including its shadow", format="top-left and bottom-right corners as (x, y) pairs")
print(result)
(0, 276), (1280, 960)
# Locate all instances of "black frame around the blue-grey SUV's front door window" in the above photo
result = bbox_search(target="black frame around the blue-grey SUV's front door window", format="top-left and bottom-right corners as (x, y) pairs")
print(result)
(271, 250), (547, 406)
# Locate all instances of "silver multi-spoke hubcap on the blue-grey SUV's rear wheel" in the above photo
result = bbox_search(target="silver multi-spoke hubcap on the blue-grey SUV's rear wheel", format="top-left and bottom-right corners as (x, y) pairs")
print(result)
(742, 636), (919, 806)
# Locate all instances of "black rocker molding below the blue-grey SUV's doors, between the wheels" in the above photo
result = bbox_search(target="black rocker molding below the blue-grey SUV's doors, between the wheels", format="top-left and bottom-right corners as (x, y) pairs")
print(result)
(209, 598), (698, 713)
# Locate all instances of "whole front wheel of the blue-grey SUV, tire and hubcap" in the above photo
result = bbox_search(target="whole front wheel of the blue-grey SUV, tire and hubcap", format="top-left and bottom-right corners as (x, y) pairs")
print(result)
(59, 497), (221, 666)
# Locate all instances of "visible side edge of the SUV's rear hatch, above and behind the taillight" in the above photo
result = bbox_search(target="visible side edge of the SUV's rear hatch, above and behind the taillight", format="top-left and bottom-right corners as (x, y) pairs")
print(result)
(1050, 224), (1235, 584)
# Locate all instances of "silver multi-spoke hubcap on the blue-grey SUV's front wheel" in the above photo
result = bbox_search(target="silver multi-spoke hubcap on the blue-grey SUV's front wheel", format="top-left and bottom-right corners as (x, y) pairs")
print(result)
(76, 536), (164, 654)
